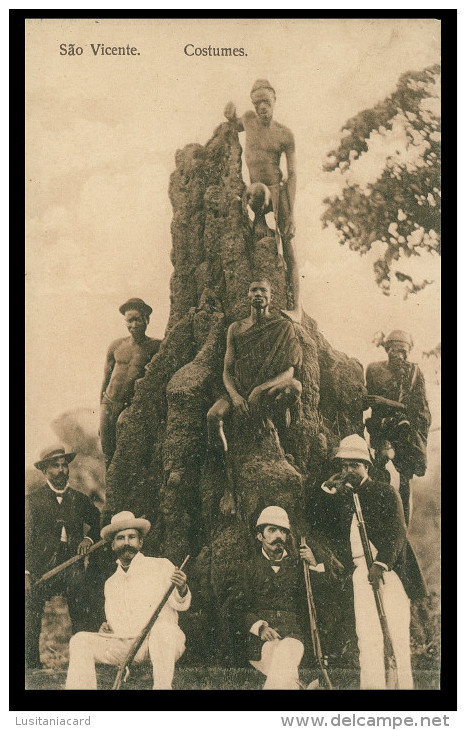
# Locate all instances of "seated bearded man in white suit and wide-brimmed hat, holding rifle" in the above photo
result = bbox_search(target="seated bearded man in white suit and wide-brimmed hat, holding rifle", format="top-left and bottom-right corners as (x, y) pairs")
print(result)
(66, 512), (191, 689)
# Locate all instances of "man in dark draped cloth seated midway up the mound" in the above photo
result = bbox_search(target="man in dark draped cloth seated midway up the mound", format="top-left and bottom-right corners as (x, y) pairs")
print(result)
(207, 279), (302, 513)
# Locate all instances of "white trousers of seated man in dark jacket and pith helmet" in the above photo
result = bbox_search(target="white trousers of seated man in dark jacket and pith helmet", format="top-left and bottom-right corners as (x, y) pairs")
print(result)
(250, 637), (304, 689)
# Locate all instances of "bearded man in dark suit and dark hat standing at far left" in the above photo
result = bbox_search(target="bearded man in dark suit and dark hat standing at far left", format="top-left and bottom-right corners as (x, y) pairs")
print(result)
(25, 446), (100, 669)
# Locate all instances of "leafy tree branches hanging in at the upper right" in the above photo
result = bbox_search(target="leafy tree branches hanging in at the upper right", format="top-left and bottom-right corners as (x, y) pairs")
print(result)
(322, 65), (440, 296)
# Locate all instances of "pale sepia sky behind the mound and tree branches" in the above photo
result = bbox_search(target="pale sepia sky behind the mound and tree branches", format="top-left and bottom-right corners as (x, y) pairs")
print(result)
(26, 19), (440, 465)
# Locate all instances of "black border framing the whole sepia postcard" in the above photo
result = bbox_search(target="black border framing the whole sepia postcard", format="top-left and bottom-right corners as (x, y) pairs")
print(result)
(13, 9), (457, 721)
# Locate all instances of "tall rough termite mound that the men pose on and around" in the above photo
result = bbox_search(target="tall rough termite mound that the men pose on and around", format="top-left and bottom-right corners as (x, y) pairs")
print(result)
(103, 123), (365, 663)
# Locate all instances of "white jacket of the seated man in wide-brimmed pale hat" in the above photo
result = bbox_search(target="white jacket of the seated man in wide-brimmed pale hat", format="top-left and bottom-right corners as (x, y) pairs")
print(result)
(105, 553), (191, 638)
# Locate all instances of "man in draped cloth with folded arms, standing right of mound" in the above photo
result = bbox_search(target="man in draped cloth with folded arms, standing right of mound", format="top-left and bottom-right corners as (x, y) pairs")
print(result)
(366, 330), (431, 524)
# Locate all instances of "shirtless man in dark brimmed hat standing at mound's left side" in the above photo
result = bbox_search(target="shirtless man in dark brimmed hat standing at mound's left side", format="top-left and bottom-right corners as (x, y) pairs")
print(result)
(99, 297), (160, 469)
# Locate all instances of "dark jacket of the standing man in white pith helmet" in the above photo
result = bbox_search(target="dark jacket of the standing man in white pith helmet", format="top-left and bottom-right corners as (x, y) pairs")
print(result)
(310, 479), (426, 600)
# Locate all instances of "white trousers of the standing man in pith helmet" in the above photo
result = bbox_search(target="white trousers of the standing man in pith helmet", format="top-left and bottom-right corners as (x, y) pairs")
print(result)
(353, 558), (413, 689)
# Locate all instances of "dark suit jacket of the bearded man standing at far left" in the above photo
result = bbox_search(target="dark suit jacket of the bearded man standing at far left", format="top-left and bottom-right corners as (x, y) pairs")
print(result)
(26, 485), (100, 578)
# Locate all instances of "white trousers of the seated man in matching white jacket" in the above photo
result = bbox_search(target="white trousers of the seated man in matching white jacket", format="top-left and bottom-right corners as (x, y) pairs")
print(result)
(66, 622), (185, 689)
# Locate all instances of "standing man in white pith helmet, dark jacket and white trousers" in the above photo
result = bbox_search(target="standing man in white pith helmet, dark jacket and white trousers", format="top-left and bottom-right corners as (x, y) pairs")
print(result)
(311, 434), (425, 689)
